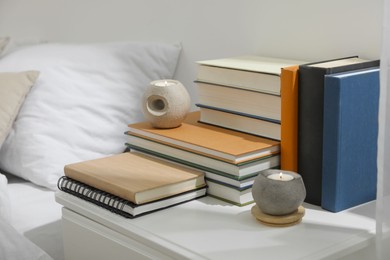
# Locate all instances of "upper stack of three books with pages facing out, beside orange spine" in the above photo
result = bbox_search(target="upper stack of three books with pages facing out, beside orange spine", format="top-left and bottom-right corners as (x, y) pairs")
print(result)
(196, 56), (304, 140)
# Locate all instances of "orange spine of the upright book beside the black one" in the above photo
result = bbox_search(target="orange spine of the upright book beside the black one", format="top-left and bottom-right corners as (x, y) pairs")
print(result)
(280, 66), (299, 172)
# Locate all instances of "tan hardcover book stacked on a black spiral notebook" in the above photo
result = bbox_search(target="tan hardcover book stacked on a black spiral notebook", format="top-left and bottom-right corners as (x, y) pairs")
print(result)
(58, 152), (206, 218)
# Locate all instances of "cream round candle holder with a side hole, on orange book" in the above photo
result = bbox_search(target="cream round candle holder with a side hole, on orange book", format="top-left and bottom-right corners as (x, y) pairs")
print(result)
(142, 79), (191, 128)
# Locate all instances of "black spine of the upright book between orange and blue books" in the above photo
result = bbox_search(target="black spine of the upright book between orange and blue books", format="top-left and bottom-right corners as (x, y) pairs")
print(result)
(298, 66), (325, 205)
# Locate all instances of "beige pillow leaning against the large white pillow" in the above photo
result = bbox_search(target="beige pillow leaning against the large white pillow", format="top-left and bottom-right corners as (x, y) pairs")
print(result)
(0, 71), (39, 147)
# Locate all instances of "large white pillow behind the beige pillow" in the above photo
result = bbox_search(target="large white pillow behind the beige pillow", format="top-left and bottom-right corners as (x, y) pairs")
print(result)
(0, 42), (181, 189)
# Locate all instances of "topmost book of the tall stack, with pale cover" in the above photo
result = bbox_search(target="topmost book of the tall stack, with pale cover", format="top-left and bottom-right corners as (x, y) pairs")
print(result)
(197, 55), (303, 95)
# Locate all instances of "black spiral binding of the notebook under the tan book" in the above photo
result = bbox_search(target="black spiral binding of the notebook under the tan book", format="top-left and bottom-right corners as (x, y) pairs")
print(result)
(57, 176), (134, 218)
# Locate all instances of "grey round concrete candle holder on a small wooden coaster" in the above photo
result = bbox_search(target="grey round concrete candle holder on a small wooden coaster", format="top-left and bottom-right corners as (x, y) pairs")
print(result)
(252, 169), (306, 216)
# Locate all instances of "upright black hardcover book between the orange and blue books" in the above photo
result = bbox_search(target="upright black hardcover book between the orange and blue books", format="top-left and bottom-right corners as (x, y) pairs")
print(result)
(298, 57), (379, 205)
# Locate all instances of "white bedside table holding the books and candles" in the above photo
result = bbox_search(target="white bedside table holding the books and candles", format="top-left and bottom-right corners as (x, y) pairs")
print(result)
(56, 192), (375, 260)
